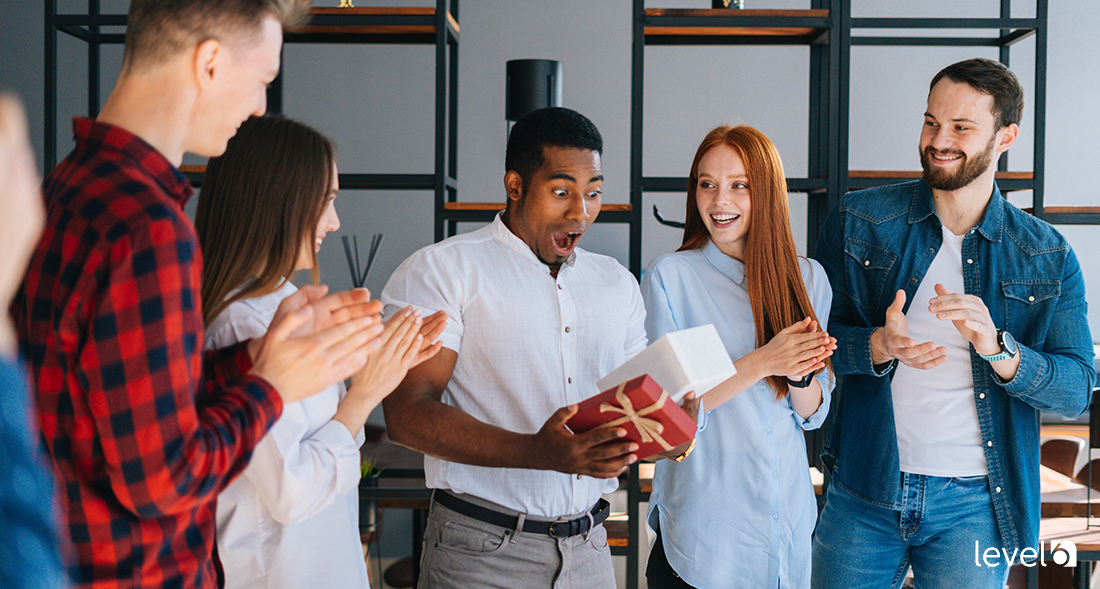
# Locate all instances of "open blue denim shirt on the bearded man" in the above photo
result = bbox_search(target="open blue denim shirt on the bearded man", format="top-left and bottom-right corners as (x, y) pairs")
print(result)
(815, 179), (1096, 552)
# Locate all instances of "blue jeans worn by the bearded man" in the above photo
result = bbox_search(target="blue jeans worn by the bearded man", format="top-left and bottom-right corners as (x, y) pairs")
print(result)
(811, 472), (1010, 589)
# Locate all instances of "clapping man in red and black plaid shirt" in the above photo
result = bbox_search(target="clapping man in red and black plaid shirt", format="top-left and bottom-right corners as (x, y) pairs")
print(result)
(12, 0), (382, 588)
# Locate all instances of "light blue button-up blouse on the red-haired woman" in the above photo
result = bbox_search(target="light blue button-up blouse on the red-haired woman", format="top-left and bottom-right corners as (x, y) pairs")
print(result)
(641, 242), (834, 589)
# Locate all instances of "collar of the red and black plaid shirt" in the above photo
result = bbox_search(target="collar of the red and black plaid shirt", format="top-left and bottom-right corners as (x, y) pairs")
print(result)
(73, 117), (195, 208)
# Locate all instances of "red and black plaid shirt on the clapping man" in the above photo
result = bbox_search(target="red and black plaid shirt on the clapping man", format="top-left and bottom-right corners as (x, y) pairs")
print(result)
(12, 118), (283, 588)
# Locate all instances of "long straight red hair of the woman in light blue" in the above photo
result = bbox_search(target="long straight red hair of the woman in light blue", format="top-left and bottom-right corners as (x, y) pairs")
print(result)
(677, 124), (832, 400)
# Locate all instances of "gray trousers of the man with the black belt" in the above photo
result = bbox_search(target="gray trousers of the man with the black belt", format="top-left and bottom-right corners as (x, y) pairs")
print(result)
(419, 493), (615, 589)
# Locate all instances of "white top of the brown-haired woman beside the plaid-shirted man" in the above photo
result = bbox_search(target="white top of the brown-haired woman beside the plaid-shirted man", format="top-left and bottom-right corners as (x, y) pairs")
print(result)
(206, 283), (369, 589)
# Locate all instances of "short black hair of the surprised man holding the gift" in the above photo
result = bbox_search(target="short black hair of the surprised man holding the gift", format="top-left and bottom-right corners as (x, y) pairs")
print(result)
(504, 107), (604, 189)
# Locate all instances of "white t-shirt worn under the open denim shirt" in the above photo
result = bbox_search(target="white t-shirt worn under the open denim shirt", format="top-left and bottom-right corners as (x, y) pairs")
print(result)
(891, 227), (988, 477)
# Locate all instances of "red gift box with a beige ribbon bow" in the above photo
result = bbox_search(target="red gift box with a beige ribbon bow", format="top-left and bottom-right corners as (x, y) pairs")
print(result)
(565, 374), (695, 458)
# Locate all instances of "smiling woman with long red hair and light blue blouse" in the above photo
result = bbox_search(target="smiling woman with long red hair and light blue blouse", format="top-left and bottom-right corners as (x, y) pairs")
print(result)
(641, 126), (836, 589)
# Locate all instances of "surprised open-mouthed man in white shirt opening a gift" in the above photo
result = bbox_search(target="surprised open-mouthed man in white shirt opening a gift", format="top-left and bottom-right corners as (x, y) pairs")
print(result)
(382, 108), (646, 589)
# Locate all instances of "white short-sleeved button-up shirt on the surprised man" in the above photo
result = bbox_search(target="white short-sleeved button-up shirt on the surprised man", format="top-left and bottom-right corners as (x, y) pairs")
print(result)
(382, 215), (646, 517)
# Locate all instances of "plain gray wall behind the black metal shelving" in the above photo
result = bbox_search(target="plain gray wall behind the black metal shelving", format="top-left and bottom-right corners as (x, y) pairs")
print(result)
(0, 0), (1100, 572)
